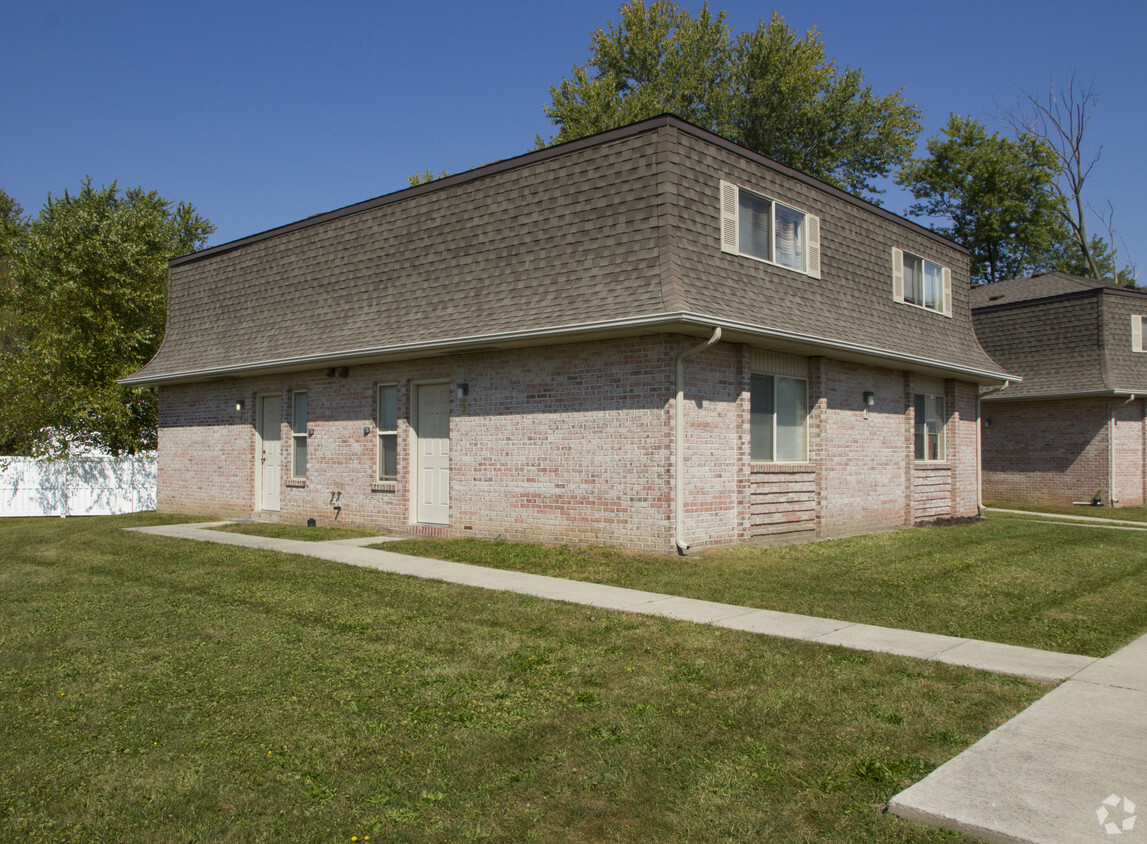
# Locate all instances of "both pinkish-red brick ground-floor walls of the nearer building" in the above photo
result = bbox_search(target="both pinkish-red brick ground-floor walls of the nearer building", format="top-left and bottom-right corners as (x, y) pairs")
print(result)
(159, 336), (975, 550)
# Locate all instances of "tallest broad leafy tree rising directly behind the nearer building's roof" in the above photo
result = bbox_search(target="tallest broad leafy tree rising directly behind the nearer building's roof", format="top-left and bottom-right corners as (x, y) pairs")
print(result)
(537, 0), (920, 198)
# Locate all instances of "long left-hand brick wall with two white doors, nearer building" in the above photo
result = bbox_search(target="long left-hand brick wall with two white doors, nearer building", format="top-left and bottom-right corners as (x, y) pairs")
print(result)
(159, 338), (679, 549)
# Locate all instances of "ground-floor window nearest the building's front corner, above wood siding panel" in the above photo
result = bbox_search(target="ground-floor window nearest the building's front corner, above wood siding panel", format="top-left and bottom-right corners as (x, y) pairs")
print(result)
(749, 375), (809, 463)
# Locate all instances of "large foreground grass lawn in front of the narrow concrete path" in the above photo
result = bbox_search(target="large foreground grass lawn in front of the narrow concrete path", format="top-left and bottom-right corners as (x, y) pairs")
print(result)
(0, 515), (1047, 842)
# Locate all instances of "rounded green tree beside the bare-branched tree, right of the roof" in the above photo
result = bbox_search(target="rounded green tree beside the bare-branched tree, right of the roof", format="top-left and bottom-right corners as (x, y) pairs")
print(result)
(896, 115), (1062, 282)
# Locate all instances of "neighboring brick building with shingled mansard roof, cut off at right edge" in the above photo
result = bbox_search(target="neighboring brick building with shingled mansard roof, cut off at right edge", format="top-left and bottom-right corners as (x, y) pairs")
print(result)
(972, 273), (1147, 506)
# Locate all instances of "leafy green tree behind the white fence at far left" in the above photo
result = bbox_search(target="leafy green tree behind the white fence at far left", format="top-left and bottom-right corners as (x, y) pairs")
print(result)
(0, 179), (214, 454)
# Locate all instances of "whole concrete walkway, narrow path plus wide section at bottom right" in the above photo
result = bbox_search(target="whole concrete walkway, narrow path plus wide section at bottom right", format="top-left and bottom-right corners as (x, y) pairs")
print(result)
(131, 522), (1147, 844)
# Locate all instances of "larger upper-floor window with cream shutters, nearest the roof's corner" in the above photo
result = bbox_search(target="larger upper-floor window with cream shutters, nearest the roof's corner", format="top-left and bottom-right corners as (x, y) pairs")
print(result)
(720, 181), (820, 279)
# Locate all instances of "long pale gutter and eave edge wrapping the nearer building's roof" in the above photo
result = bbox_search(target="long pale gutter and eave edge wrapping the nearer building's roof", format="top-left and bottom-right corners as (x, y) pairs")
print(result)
(117, 312), (1020, 386)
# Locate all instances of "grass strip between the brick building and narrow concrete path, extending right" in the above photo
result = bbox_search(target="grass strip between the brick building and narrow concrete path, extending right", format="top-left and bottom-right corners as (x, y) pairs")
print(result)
(380, 514), (1147, 656)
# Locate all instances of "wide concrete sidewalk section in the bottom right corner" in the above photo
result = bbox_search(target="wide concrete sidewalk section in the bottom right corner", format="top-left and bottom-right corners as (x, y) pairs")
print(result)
(889, 636), (1147, 843)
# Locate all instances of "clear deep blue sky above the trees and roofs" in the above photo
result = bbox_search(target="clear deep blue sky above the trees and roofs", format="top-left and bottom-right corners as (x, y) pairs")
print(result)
(0, 0), (1147, 274)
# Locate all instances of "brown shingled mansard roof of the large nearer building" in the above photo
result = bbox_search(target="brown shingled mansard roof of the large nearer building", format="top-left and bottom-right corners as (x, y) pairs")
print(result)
(125, 117), (1006, 384)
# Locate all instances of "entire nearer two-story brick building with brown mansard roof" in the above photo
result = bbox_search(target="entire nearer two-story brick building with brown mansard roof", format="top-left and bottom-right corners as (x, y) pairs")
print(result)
(125, 117), (1013, 550)
